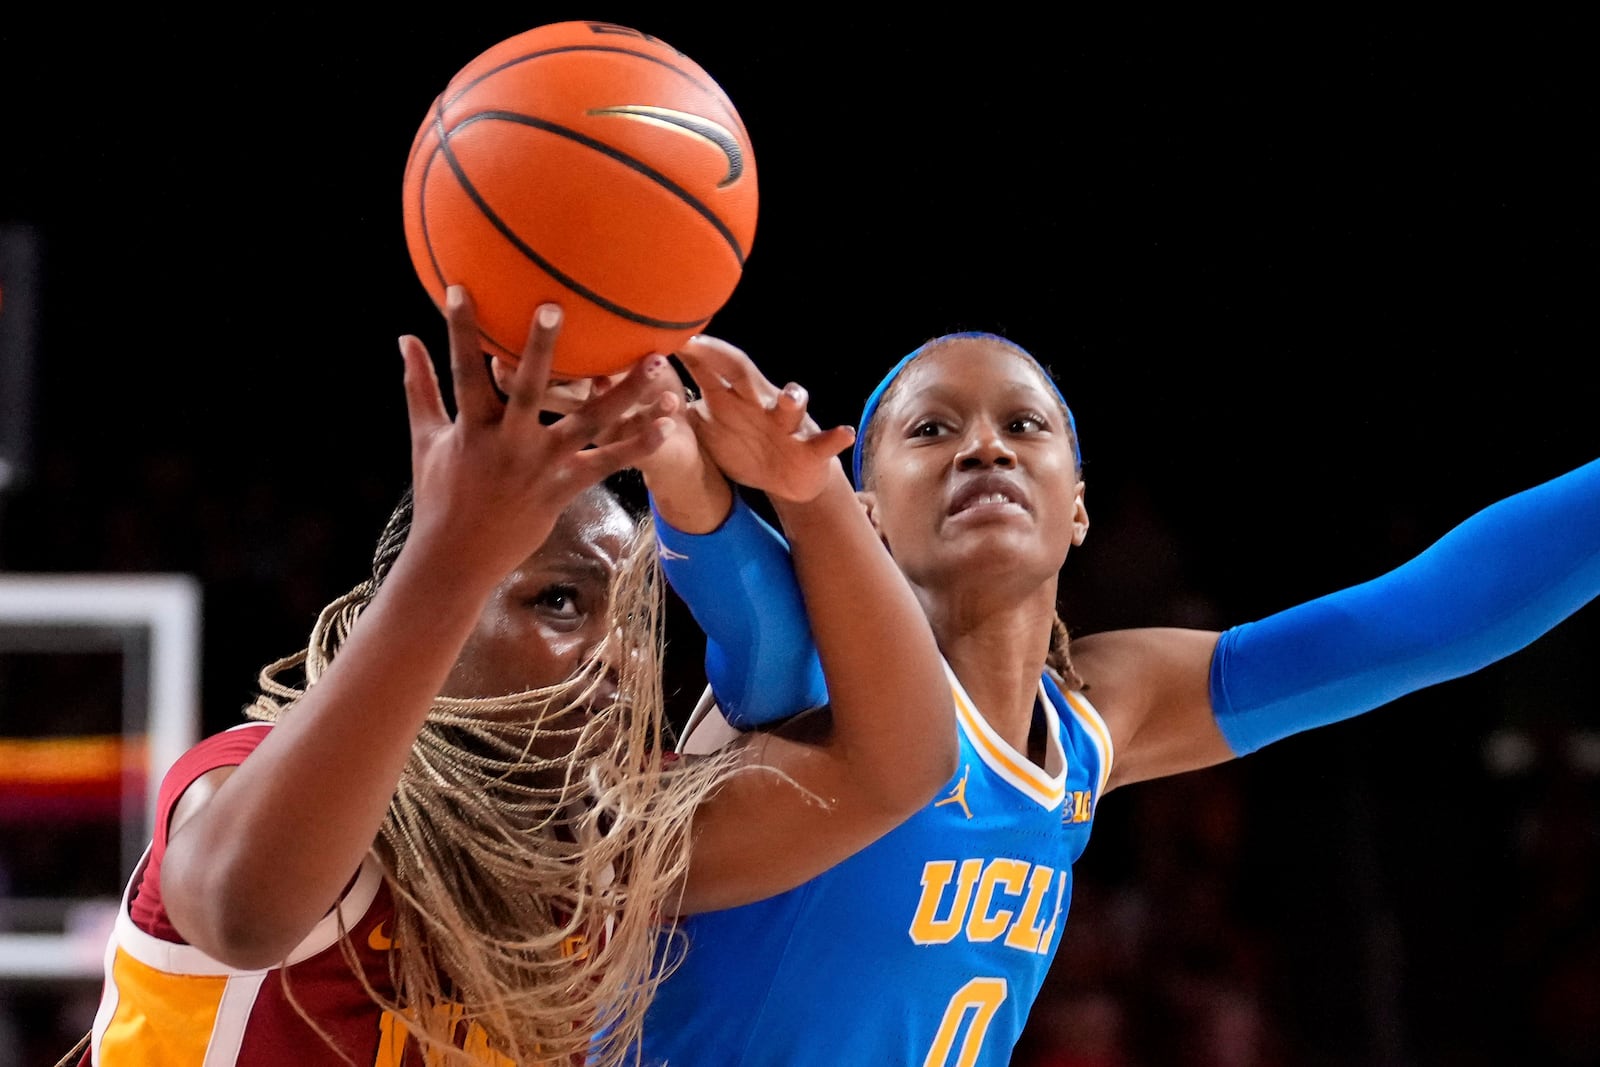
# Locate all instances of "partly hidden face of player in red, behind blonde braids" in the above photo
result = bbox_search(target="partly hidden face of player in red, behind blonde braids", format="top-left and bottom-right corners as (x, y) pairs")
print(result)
(443, 491), (634, 716)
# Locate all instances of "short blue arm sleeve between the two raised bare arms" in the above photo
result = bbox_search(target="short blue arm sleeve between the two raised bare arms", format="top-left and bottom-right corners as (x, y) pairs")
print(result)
(650, 493), (827, 729)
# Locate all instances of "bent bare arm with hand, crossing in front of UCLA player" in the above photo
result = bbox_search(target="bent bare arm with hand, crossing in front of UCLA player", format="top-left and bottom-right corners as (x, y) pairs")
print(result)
(656, 338), (957, 912)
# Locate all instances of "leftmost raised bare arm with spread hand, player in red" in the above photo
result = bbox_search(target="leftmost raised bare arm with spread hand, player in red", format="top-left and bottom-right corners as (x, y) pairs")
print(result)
(162, 290), (670, 968)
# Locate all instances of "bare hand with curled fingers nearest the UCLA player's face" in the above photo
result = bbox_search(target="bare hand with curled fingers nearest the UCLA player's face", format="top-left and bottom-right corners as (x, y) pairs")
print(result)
(677, 336), (856, 502)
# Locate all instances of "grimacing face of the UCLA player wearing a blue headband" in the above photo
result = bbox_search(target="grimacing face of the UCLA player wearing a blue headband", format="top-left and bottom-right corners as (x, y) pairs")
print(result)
(866, 338), (1088, 587)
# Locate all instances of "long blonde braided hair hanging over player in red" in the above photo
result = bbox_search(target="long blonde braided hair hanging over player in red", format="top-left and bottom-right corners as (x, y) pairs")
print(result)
(245, 494), (731, 1067)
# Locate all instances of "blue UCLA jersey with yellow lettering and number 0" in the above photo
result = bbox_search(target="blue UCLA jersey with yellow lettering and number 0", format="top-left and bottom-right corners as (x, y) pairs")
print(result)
(643, 667), (1112, 1067)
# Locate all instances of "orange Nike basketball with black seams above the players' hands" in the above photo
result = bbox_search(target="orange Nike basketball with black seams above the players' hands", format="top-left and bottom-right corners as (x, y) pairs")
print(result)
(403, 21), (757, 378)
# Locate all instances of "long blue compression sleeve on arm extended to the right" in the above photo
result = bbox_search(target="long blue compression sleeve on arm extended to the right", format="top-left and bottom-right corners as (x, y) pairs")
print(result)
(1211, 461), (1600, 755)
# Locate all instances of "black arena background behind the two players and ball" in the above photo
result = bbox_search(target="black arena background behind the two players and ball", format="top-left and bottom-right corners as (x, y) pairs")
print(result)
(0, 5), (1600, 1067)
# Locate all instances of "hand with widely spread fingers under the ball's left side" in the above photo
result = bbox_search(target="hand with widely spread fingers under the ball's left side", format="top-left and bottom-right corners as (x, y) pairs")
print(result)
(400, 286), (675, 581)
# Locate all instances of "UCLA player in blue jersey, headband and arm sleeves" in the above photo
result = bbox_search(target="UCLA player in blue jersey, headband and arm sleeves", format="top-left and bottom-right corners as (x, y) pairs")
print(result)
(643, 334), (1600, 1067)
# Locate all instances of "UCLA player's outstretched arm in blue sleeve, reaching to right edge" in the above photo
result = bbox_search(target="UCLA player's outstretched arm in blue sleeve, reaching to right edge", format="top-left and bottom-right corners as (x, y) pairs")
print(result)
(1080, 461), (1600, 793)
